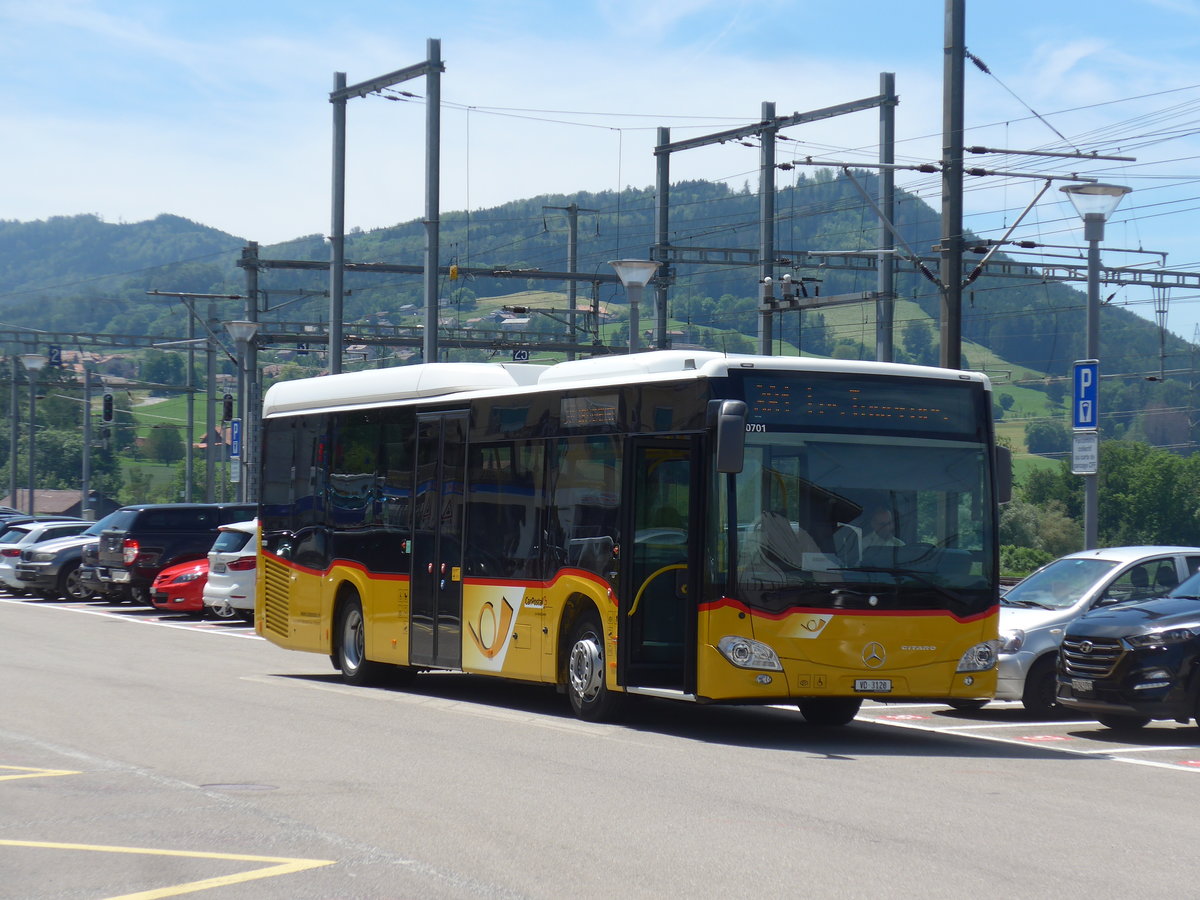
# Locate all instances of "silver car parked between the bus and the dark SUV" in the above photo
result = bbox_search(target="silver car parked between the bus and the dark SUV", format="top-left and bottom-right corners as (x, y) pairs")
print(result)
(996, 546), (1200, 715)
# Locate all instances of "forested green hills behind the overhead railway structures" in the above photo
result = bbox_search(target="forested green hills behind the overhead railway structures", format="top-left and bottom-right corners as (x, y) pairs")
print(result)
(0, 172), (1190, 443)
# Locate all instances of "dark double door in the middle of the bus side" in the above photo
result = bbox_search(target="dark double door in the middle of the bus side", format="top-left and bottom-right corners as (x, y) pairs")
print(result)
(408, 412), (467, 668)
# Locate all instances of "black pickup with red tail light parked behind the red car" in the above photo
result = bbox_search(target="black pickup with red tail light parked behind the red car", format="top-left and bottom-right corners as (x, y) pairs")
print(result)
(96, 503), (258, 604)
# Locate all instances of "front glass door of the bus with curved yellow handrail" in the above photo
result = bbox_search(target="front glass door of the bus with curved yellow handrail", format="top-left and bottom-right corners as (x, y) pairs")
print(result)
(617, 438), (702, 692)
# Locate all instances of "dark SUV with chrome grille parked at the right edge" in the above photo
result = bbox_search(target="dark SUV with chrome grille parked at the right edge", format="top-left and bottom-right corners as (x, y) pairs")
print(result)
(1058, 574), (1200, 731)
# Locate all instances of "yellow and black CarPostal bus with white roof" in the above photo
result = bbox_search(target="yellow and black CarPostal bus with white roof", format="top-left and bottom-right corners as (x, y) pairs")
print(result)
(256, 350), (1004, 724)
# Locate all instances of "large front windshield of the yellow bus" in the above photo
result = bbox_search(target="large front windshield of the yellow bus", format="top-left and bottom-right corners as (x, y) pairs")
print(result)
(716, 432), (996, 617)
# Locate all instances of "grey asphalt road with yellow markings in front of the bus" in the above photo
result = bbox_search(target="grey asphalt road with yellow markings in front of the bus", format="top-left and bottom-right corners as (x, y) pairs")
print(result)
(0, 599), (1200, 900)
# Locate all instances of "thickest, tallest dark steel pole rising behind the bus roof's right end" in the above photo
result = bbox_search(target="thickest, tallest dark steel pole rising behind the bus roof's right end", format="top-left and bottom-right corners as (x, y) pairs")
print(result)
(938, 0), (966, 368)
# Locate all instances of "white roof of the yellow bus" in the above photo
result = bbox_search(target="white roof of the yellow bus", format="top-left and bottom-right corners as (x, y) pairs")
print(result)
(263, 350), (991, 418)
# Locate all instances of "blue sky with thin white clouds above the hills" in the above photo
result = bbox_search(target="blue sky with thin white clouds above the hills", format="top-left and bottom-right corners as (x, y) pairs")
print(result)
(7, 0), (1200, 340)
